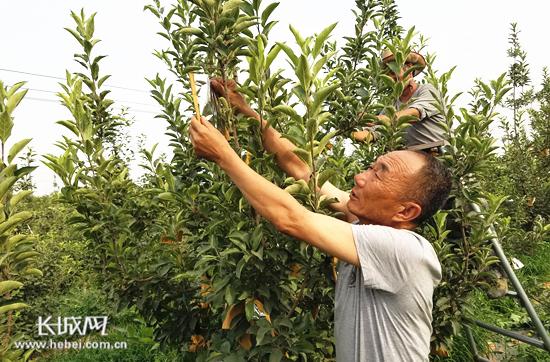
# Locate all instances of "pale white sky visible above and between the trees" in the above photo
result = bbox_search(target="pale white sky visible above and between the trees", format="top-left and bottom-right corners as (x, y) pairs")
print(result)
(0, 0), (550, 195)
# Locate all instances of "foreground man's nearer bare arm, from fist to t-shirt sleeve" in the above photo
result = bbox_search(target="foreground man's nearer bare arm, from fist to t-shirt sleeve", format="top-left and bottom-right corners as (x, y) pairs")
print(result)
(190, 118), (359, 265)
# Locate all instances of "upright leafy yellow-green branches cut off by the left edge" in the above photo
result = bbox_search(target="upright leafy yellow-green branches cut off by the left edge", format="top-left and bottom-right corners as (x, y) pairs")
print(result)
(0, 82), (42, 361)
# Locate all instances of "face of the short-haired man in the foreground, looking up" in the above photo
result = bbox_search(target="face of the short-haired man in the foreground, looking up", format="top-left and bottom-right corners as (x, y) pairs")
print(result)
(348, 151), (425, 226)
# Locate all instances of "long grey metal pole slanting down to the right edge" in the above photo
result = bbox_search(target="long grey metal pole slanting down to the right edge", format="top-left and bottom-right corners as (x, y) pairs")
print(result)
(471, 203), (550, 352)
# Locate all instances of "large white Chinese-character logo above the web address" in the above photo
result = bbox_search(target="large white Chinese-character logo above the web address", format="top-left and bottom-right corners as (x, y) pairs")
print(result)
(36, 316), (108, 336)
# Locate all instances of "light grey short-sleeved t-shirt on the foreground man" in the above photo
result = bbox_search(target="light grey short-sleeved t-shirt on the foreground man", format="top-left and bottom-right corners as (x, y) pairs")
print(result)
(334, 225), (441, 362)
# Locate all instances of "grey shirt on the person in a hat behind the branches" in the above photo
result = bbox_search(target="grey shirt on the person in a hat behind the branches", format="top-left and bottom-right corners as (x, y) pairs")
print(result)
(395, 84), (445, 149)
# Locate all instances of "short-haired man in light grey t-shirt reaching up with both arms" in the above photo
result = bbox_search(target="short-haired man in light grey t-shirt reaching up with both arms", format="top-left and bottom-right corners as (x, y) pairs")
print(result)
(190, 75), (450, 362)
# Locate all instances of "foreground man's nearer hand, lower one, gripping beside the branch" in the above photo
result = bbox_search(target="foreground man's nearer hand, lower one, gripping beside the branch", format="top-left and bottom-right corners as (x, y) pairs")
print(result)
(189, 117), (233, 163)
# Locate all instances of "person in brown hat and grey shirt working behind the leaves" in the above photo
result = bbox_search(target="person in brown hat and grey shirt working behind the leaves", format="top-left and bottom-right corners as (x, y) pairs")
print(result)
(352, 50), (445, 151)
